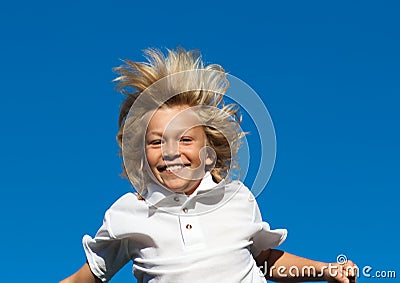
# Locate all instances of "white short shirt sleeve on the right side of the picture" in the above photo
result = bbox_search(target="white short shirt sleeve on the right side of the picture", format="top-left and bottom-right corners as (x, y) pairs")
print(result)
(251, 200), (287, 257)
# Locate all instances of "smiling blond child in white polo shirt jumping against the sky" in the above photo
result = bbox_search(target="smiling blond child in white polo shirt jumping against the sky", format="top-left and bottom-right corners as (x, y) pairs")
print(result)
(62, 49), (355, 283)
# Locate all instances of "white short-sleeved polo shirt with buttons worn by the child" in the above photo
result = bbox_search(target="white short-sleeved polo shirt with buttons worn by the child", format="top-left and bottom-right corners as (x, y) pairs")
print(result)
(83, 173), (287, 283)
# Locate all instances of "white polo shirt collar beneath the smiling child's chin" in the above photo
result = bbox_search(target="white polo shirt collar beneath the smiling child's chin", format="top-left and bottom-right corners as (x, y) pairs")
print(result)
(143, 172), (225, 209)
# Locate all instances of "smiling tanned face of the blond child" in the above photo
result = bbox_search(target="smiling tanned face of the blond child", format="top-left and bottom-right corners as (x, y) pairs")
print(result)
(145, 106), (213, 194)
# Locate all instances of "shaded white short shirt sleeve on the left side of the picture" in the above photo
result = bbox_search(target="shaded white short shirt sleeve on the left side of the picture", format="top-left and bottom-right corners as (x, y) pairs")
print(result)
(82, 211), (131, 282)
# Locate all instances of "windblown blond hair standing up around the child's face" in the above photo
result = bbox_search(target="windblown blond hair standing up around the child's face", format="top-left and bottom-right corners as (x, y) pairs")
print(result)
(114, 48), (244, 193)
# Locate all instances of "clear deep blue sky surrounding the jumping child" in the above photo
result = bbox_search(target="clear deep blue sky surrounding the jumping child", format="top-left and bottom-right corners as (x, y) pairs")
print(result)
(0, 1), (400, 282)
